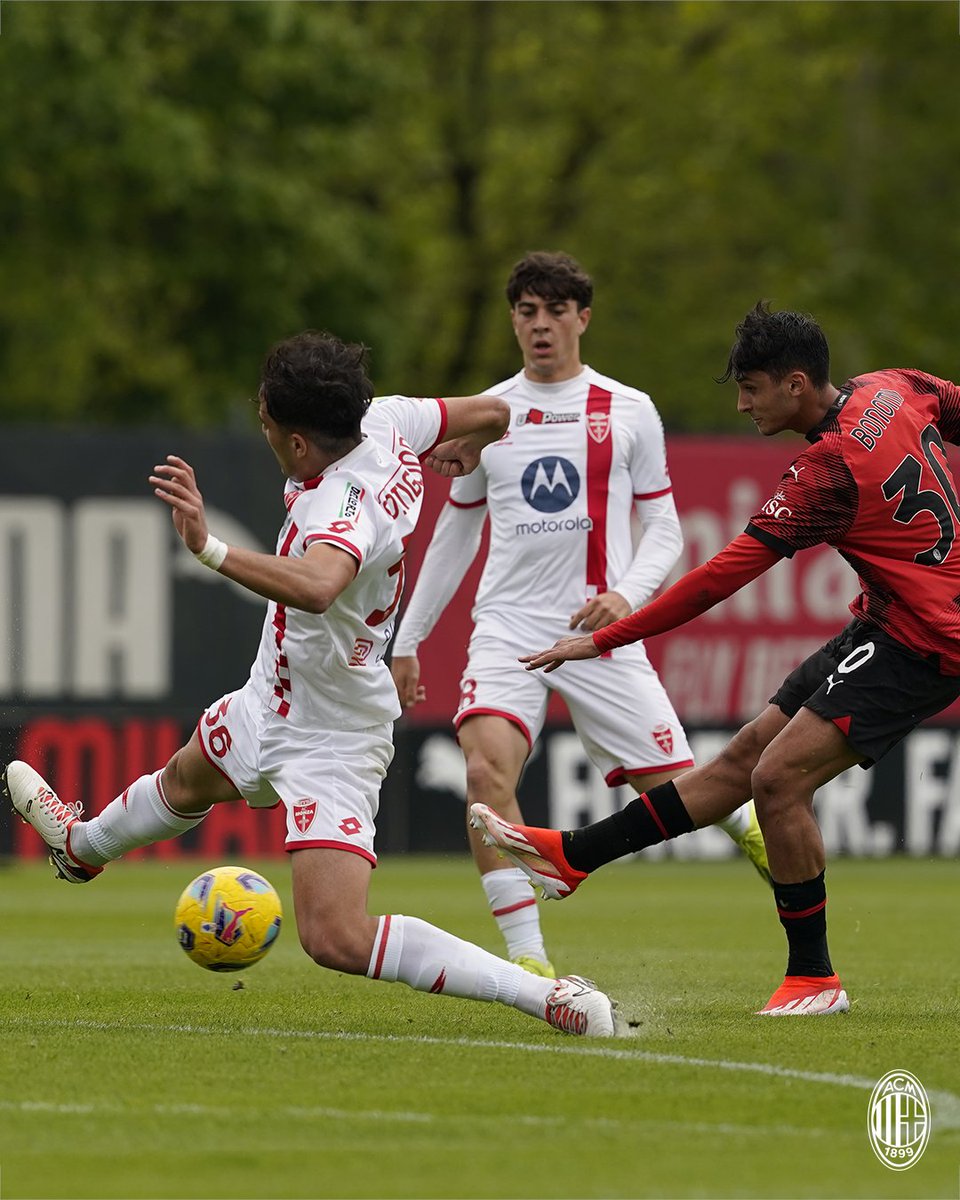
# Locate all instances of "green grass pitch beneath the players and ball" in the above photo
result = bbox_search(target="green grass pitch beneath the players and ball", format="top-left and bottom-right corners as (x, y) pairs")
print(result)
(0, 857), (960, 1200)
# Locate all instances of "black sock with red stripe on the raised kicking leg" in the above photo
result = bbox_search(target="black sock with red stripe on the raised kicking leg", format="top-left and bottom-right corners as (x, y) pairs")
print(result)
(562, 780), (694, 871)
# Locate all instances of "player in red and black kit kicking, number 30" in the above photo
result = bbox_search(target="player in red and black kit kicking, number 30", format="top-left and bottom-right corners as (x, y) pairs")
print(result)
(472, 304), (960, 1016)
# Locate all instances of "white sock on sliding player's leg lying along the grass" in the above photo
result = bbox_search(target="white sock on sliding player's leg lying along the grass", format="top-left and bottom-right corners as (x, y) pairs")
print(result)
(367, 914), (556, 1020)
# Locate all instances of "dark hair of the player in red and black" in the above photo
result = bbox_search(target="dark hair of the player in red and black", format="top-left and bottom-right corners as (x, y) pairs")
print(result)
(716, 300), (830, 388)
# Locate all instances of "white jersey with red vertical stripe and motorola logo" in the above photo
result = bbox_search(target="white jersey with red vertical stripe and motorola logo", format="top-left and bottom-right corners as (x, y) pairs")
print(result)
(450, 367), (671, 648)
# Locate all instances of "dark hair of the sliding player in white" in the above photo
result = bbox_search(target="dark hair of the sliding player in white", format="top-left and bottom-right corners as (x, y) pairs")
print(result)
(260, 329), (373, 444)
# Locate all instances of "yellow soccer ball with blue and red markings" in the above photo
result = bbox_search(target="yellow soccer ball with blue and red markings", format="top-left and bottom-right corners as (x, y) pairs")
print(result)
(173, 866), (283, 971)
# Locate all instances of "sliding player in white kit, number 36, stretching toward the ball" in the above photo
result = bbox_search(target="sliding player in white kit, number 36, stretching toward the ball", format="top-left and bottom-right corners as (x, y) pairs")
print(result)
(4, 331), (614, 1037)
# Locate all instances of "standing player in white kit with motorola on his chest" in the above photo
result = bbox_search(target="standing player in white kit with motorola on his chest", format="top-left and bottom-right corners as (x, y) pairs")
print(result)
(392, 252), (769, 976)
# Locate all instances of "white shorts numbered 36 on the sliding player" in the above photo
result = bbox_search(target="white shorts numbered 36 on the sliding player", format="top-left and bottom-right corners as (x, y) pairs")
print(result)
(197, 688), (394, 866)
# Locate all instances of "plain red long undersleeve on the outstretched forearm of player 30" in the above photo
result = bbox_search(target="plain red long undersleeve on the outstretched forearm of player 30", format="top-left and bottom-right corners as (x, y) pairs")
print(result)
(593, 533), (784, 654)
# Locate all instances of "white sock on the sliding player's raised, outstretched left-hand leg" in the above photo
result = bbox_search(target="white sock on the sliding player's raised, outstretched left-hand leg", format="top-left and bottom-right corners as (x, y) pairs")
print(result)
(70, 770), (210, 866)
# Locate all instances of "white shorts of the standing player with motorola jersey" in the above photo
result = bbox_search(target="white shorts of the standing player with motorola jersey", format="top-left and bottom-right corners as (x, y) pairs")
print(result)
(454, 634), (694, 787)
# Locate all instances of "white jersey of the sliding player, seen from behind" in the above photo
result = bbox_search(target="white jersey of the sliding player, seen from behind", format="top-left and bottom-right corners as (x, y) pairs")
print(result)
(247, 396), (446, 730)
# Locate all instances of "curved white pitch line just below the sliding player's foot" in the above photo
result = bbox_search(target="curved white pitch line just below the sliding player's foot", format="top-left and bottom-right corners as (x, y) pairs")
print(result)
(9, 1018), (960, 1129)
